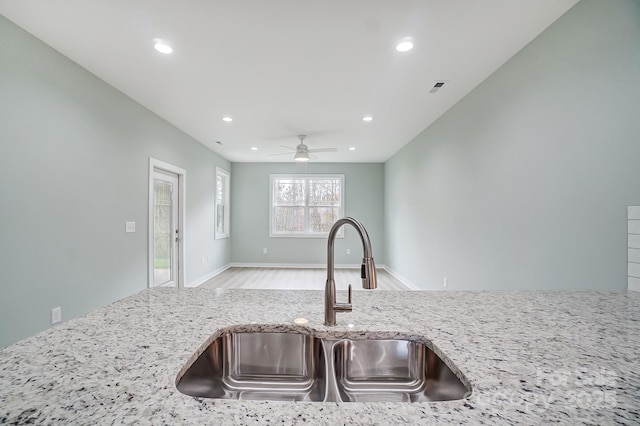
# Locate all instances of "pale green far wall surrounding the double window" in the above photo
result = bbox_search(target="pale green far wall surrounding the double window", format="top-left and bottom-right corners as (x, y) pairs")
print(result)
(231, 163), (384, 266)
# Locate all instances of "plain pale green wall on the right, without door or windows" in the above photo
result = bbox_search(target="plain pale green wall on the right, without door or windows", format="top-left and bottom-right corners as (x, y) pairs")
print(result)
(385, 0), (640, 290)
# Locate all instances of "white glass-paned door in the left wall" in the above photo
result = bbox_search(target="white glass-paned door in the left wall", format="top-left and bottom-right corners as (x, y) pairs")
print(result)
(150, 169), (181, 287)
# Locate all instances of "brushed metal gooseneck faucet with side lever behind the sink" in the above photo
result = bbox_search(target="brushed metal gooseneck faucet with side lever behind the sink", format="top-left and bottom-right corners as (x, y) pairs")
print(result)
(324, 217), (378, 325)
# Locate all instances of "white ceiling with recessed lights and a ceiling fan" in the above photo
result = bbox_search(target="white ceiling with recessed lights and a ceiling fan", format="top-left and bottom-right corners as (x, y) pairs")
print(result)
(0, 0), (577, 162)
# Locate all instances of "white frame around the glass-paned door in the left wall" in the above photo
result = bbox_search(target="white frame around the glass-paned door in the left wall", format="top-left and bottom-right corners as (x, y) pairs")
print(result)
(147, 157), (187, 287)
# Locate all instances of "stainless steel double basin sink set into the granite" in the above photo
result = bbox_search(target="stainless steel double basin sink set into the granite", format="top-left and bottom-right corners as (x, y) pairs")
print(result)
(176, 331), (471, 402)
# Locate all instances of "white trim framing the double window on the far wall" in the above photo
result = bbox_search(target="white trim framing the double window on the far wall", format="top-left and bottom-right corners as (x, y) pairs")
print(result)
(269, 173), (346, 238)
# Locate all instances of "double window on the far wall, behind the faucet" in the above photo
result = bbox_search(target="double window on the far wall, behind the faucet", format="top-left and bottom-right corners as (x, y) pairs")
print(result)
(269, 175), (344, 237)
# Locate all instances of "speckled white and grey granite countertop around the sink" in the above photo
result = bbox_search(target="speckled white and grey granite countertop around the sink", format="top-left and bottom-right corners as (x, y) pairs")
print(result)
(0, 288), (640, 425)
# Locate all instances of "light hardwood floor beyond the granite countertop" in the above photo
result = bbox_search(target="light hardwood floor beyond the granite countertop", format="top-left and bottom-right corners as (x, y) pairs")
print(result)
(200, 267), (409, 291)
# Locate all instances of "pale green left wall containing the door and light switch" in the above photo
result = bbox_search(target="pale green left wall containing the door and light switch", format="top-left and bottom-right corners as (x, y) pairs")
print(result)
(0, 17), (230, 347)
